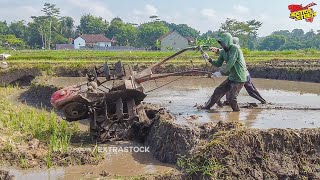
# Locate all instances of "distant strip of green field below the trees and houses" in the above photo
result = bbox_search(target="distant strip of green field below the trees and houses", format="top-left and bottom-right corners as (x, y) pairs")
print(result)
(6, 49), (320, 65)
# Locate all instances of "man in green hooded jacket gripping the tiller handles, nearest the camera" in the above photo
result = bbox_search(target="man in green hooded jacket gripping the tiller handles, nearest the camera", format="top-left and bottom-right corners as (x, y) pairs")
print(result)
(202, 33), (248, 111)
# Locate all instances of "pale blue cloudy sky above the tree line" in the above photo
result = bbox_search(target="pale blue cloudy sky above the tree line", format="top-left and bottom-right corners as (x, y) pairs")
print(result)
(0, 0), (320, 36)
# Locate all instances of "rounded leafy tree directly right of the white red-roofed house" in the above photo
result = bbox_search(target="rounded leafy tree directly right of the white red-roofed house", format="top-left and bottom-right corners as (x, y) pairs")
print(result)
(106, 18), (138, 46)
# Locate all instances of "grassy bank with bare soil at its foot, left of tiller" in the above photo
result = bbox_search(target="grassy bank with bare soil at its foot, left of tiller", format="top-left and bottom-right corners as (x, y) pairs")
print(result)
(0, 87), (100, 168)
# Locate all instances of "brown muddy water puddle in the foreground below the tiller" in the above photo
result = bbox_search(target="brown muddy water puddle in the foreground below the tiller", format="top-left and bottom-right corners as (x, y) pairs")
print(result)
(1, 142), (174, 180)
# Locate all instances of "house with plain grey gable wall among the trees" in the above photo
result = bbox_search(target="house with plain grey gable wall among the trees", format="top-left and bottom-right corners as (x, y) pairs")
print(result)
(158, 31), (193, 51)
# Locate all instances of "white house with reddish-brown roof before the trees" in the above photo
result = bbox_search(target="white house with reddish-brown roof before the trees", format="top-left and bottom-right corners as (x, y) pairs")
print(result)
(74, 34), (111, 49)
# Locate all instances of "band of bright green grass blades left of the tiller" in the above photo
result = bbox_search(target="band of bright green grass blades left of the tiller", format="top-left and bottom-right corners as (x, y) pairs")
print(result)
(0, 103), (76, 152)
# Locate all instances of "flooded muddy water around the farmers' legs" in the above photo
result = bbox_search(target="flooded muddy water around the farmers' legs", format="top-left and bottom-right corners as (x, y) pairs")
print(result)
(144, 77), (320, 129)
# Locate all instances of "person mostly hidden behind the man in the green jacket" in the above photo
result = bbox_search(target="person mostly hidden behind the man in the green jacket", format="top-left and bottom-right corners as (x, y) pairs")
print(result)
(210, 37), (267, 106)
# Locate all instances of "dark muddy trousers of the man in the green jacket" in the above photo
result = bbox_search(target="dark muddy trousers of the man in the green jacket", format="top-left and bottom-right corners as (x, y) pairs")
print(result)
(203, 79), (244, 111)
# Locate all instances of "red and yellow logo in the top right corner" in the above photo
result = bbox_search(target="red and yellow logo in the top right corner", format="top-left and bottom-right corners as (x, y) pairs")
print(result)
(288, 3), (317, 23)
